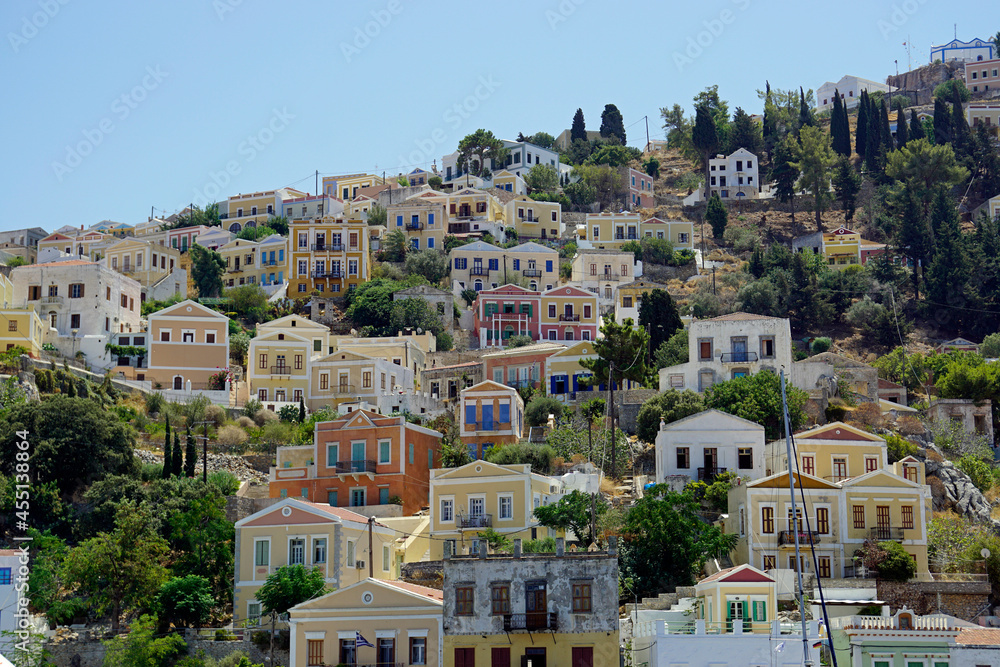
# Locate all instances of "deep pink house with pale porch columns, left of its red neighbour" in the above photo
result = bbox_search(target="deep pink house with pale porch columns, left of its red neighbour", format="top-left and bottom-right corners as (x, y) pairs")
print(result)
(474, 285), (544, 347)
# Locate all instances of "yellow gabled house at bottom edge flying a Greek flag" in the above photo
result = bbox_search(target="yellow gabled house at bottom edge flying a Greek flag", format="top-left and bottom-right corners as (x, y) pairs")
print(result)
(288, 579), (444, 667)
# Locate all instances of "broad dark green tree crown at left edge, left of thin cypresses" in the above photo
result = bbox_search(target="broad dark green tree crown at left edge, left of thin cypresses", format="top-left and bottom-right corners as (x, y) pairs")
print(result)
(0, 396), (138, 499)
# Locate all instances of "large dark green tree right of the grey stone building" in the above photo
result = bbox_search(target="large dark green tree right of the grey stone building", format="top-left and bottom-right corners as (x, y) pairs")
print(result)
(619, 484), (738, 597)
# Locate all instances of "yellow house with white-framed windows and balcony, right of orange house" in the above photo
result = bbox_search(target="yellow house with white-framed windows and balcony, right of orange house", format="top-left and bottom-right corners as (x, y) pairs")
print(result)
(429, 461), (565, 560)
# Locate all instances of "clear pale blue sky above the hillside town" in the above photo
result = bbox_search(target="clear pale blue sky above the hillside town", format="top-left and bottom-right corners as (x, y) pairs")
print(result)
(0, 0), (1000, 231)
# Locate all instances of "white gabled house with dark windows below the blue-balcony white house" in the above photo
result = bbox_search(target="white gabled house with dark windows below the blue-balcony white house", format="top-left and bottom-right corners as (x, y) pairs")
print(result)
(656, 410), (764, 486)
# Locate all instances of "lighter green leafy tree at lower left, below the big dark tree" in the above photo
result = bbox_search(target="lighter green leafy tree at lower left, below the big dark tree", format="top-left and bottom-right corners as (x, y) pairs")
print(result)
(63, 502), (167, 630)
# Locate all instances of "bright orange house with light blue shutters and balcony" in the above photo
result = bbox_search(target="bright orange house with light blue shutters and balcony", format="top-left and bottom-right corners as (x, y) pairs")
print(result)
(269, 410), (441, 515)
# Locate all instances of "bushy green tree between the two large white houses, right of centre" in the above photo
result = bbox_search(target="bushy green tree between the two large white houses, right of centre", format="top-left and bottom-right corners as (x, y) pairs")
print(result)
(705, 370), (809, 440)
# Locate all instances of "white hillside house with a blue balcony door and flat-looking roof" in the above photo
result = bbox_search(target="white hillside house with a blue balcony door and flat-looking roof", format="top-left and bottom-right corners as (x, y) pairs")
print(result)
(660, 313), (792, 391)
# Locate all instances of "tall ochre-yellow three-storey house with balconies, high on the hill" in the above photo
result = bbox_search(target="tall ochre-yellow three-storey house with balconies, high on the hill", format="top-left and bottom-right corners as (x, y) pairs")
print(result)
(288, 217), (371, 298)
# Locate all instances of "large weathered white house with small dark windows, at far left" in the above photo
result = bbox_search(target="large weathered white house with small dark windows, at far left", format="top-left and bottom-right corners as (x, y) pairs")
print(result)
(11, 259), (142, 370)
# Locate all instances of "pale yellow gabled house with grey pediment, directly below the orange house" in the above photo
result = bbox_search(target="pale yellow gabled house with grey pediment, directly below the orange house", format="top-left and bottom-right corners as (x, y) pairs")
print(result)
(233, 498), (395, 625)
